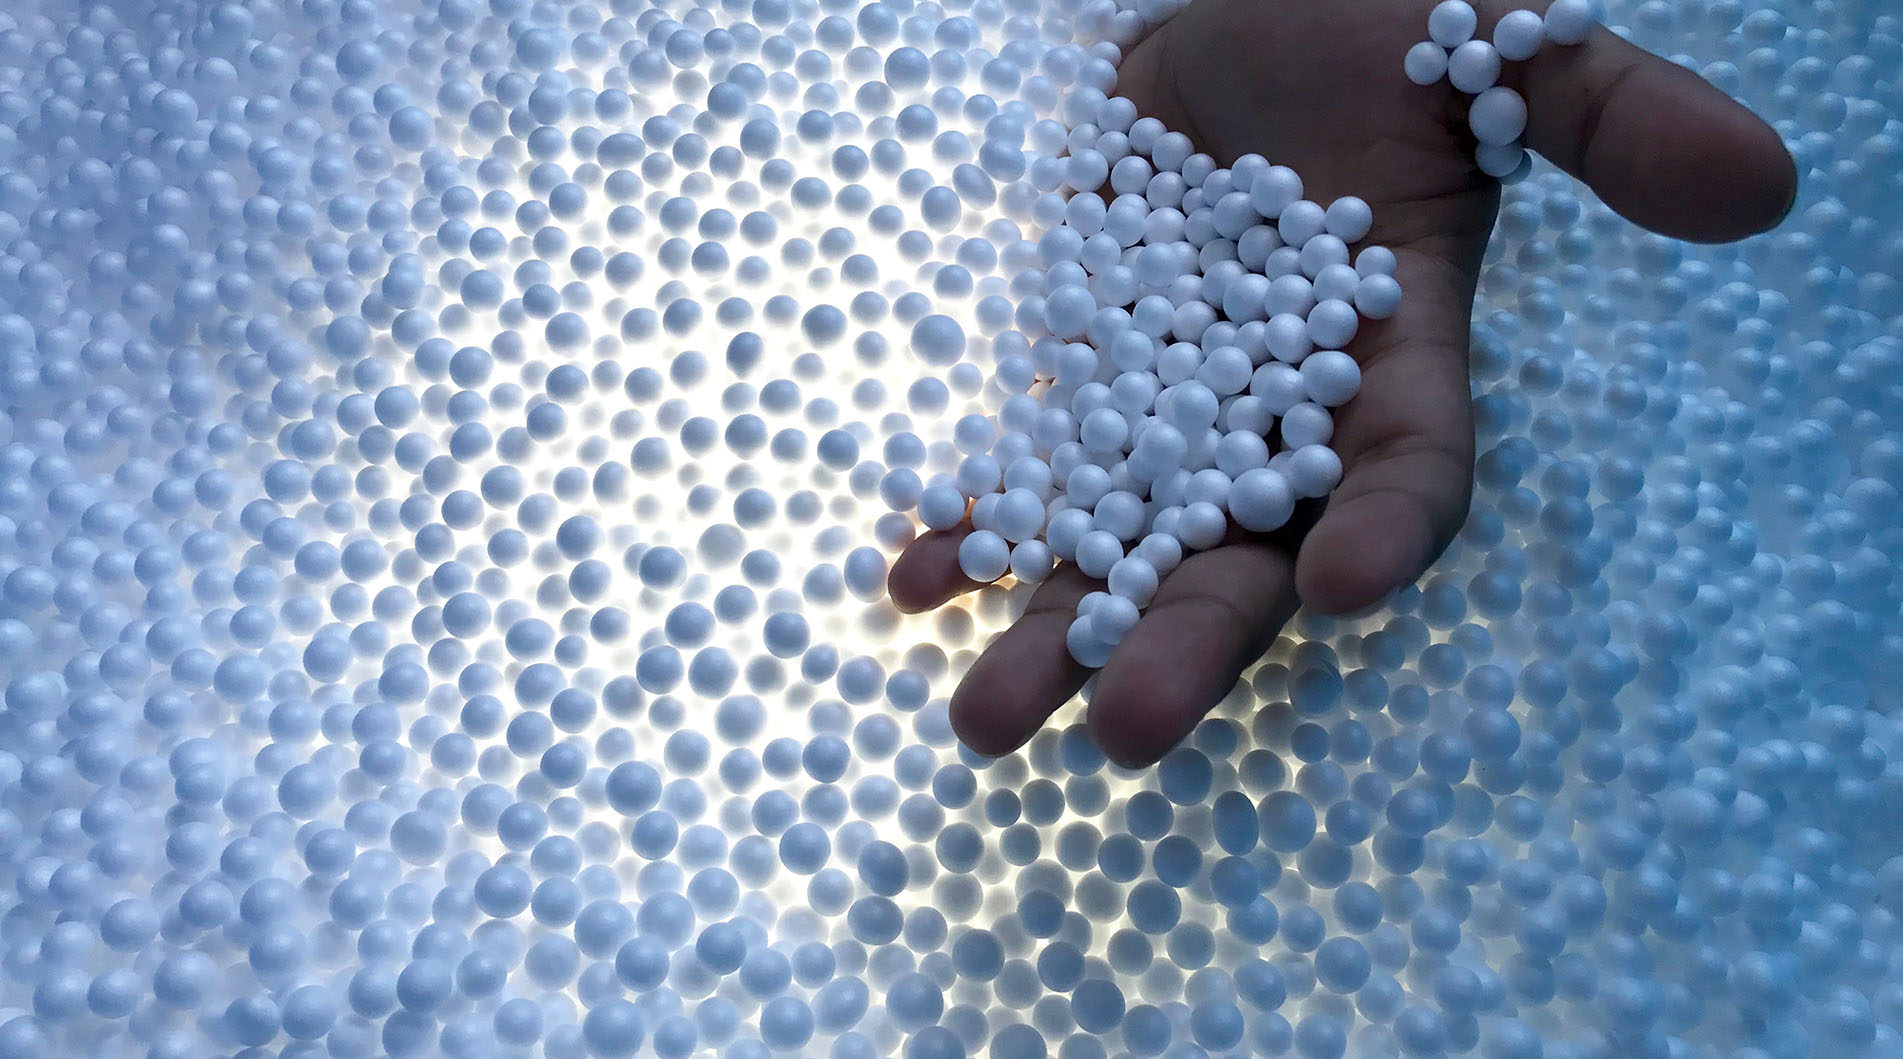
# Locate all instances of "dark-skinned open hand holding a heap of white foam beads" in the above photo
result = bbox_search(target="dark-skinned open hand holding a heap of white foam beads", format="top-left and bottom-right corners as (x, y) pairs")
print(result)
(891, 0), (1796, 768)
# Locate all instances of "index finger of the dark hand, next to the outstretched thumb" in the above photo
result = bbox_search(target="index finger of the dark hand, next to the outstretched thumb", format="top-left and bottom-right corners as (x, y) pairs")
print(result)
(1294, 248), (1473, 613)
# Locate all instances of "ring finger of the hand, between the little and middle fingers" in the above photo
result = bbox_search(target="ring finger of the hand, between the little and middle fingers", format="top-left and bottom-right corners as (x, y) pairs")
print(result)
(952, 564), (1102, 756)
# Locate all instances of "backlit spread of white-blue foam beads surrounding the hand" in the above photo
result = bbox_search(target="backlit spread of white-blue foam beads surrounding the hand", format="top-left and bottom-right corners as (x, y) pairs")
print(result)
(0, 0), (1903, 1059)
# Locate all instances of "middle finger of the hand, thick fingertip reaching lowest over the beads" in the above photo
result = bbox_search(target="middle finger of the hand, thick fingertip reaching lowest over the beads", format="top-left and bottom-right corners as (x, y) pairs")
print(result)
(1080, 541), (1296, 768)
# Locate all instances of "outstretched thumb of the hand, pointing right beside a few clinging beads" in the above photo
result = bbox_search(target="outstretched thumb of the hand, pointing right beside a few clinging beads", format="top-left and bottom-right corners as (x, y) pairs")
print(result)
(1509, 8), (1796, 242)
